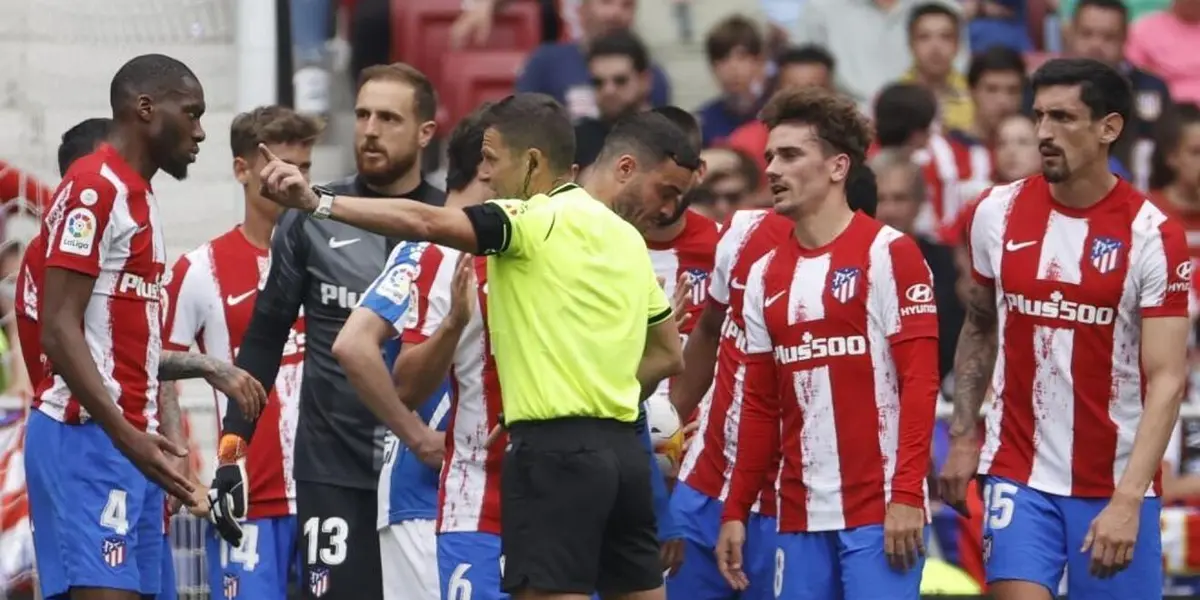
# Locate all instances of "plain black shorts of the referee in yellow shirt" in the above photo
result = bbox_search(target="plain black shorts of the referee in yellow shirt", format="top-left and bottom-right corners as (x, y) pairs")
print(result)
(500, 419), (662, 594)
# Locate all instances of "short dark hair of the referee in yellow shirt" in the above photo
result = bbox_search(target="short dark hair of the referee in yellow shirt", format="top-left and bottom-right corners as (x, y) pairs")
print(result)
(490, 92), (575, 174)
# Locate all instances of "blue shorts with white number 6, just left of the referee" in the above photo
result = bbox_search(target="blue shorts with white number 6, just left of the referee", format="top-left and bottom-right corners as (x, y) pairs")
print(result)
(438, 532), (509, 600)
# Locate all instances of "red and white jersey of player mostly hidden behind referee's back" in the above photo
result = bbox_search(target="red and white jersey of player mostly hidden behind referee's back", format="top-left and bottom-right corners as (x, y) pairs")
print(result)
(646, 210), (721, 408)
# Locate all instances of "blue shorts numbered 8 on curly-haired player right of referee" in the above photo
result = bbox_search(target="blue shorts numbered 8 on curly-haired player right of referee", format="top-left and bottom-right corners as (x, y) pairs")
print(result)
(774, 526), (929, 600)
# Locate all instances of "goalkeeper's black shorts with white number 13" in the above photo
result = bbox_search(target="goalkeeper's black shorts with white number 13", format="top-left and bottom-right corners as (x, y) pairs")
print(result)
(296, 481), (383, 600)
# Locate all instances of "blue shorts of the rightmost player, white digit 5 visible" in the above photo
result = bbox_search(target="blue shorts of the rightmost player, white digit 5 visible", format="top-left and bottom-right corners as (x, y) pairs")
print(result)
(983, 476), (1163, 599)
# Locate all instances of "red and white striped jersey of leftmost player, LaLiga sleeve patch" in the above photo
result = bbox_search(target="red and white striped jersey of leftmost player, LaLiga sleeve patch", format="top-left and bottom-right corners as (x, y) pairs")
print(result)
(34, 144), (167, 432)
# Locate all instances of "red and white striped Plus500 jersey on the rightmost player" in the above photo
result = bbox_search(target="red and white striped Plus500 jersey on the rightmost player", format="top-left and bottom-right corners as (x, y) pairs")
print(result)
(970, 175), (1192, 498)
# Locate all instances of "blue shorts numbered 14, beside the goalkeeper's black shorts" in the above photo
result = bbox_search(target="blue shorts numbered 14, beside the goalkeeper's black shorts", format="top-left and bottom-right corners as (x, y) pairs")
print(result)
(204, 516), (300, 600)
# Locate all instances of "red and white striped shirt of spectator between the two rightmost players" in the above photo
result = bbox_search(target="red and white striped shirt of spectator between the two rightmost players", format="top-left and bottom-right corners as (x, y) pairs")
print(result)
(913, 133), (992, 239)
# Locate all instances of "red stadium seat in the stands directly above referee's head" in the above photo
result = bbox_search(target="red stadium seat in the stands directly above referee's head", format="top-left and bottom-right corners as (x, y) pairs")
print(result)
(438, 50), (526, 127)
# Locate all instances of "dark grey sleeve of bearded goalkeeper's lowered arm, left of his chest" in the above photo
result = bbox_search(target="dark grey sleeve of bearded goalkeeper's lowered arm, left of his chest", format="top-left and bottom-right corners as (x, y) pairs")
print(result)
(222, 210), (308, 442)
